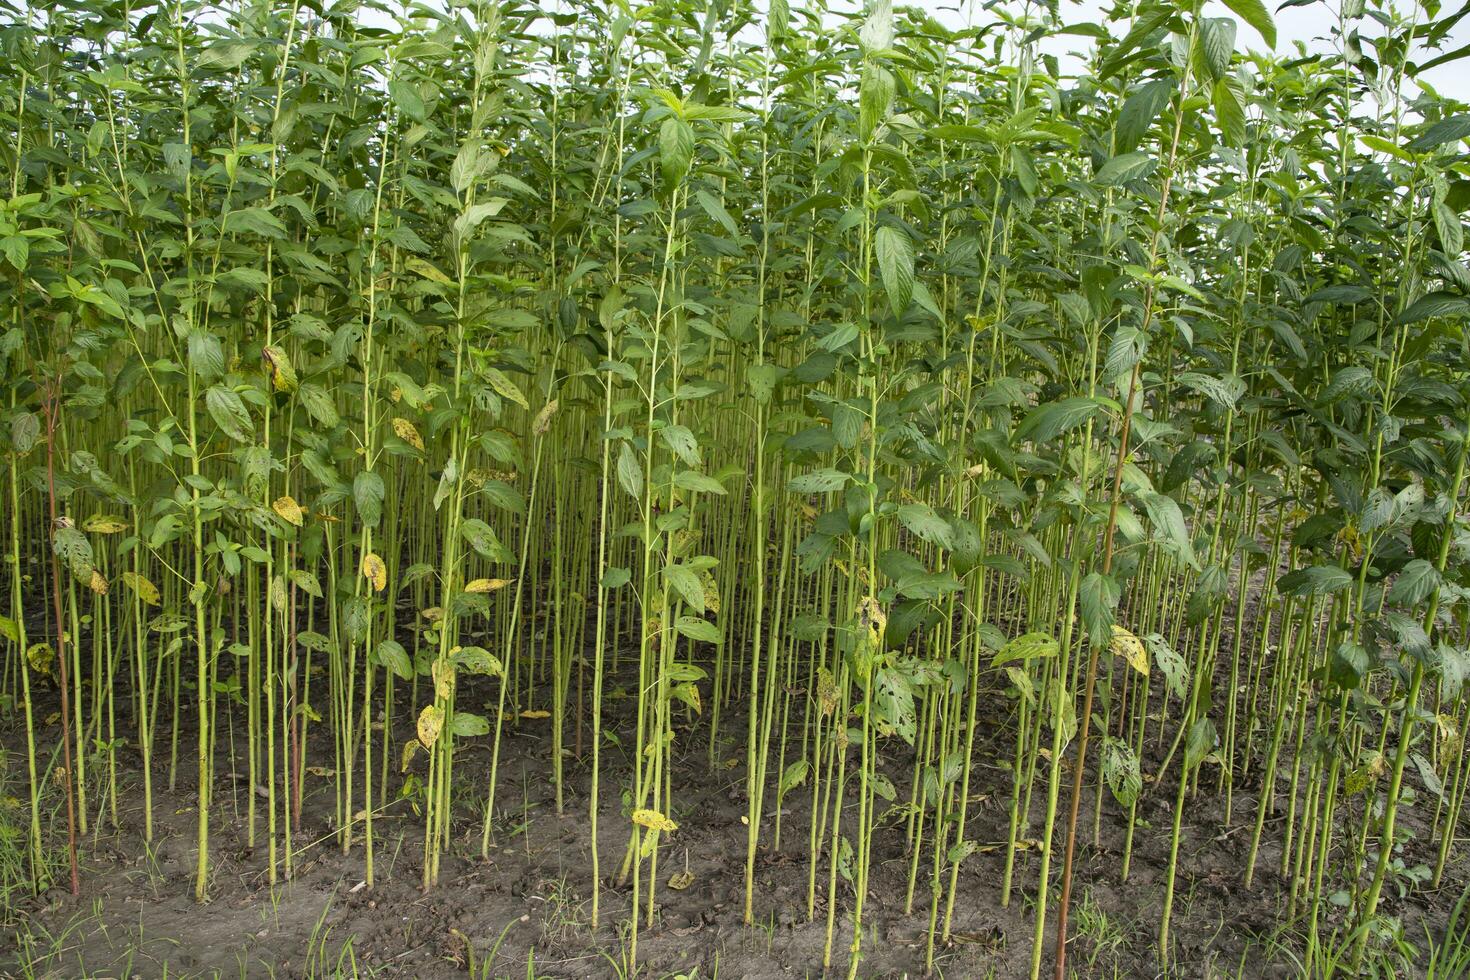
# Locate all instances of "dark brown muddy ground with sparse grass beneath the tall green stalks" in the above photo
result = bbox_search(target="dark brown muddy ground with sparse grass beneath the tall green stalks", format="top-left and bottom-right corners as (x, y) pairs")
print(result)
(0, 625), (1466, 980)
